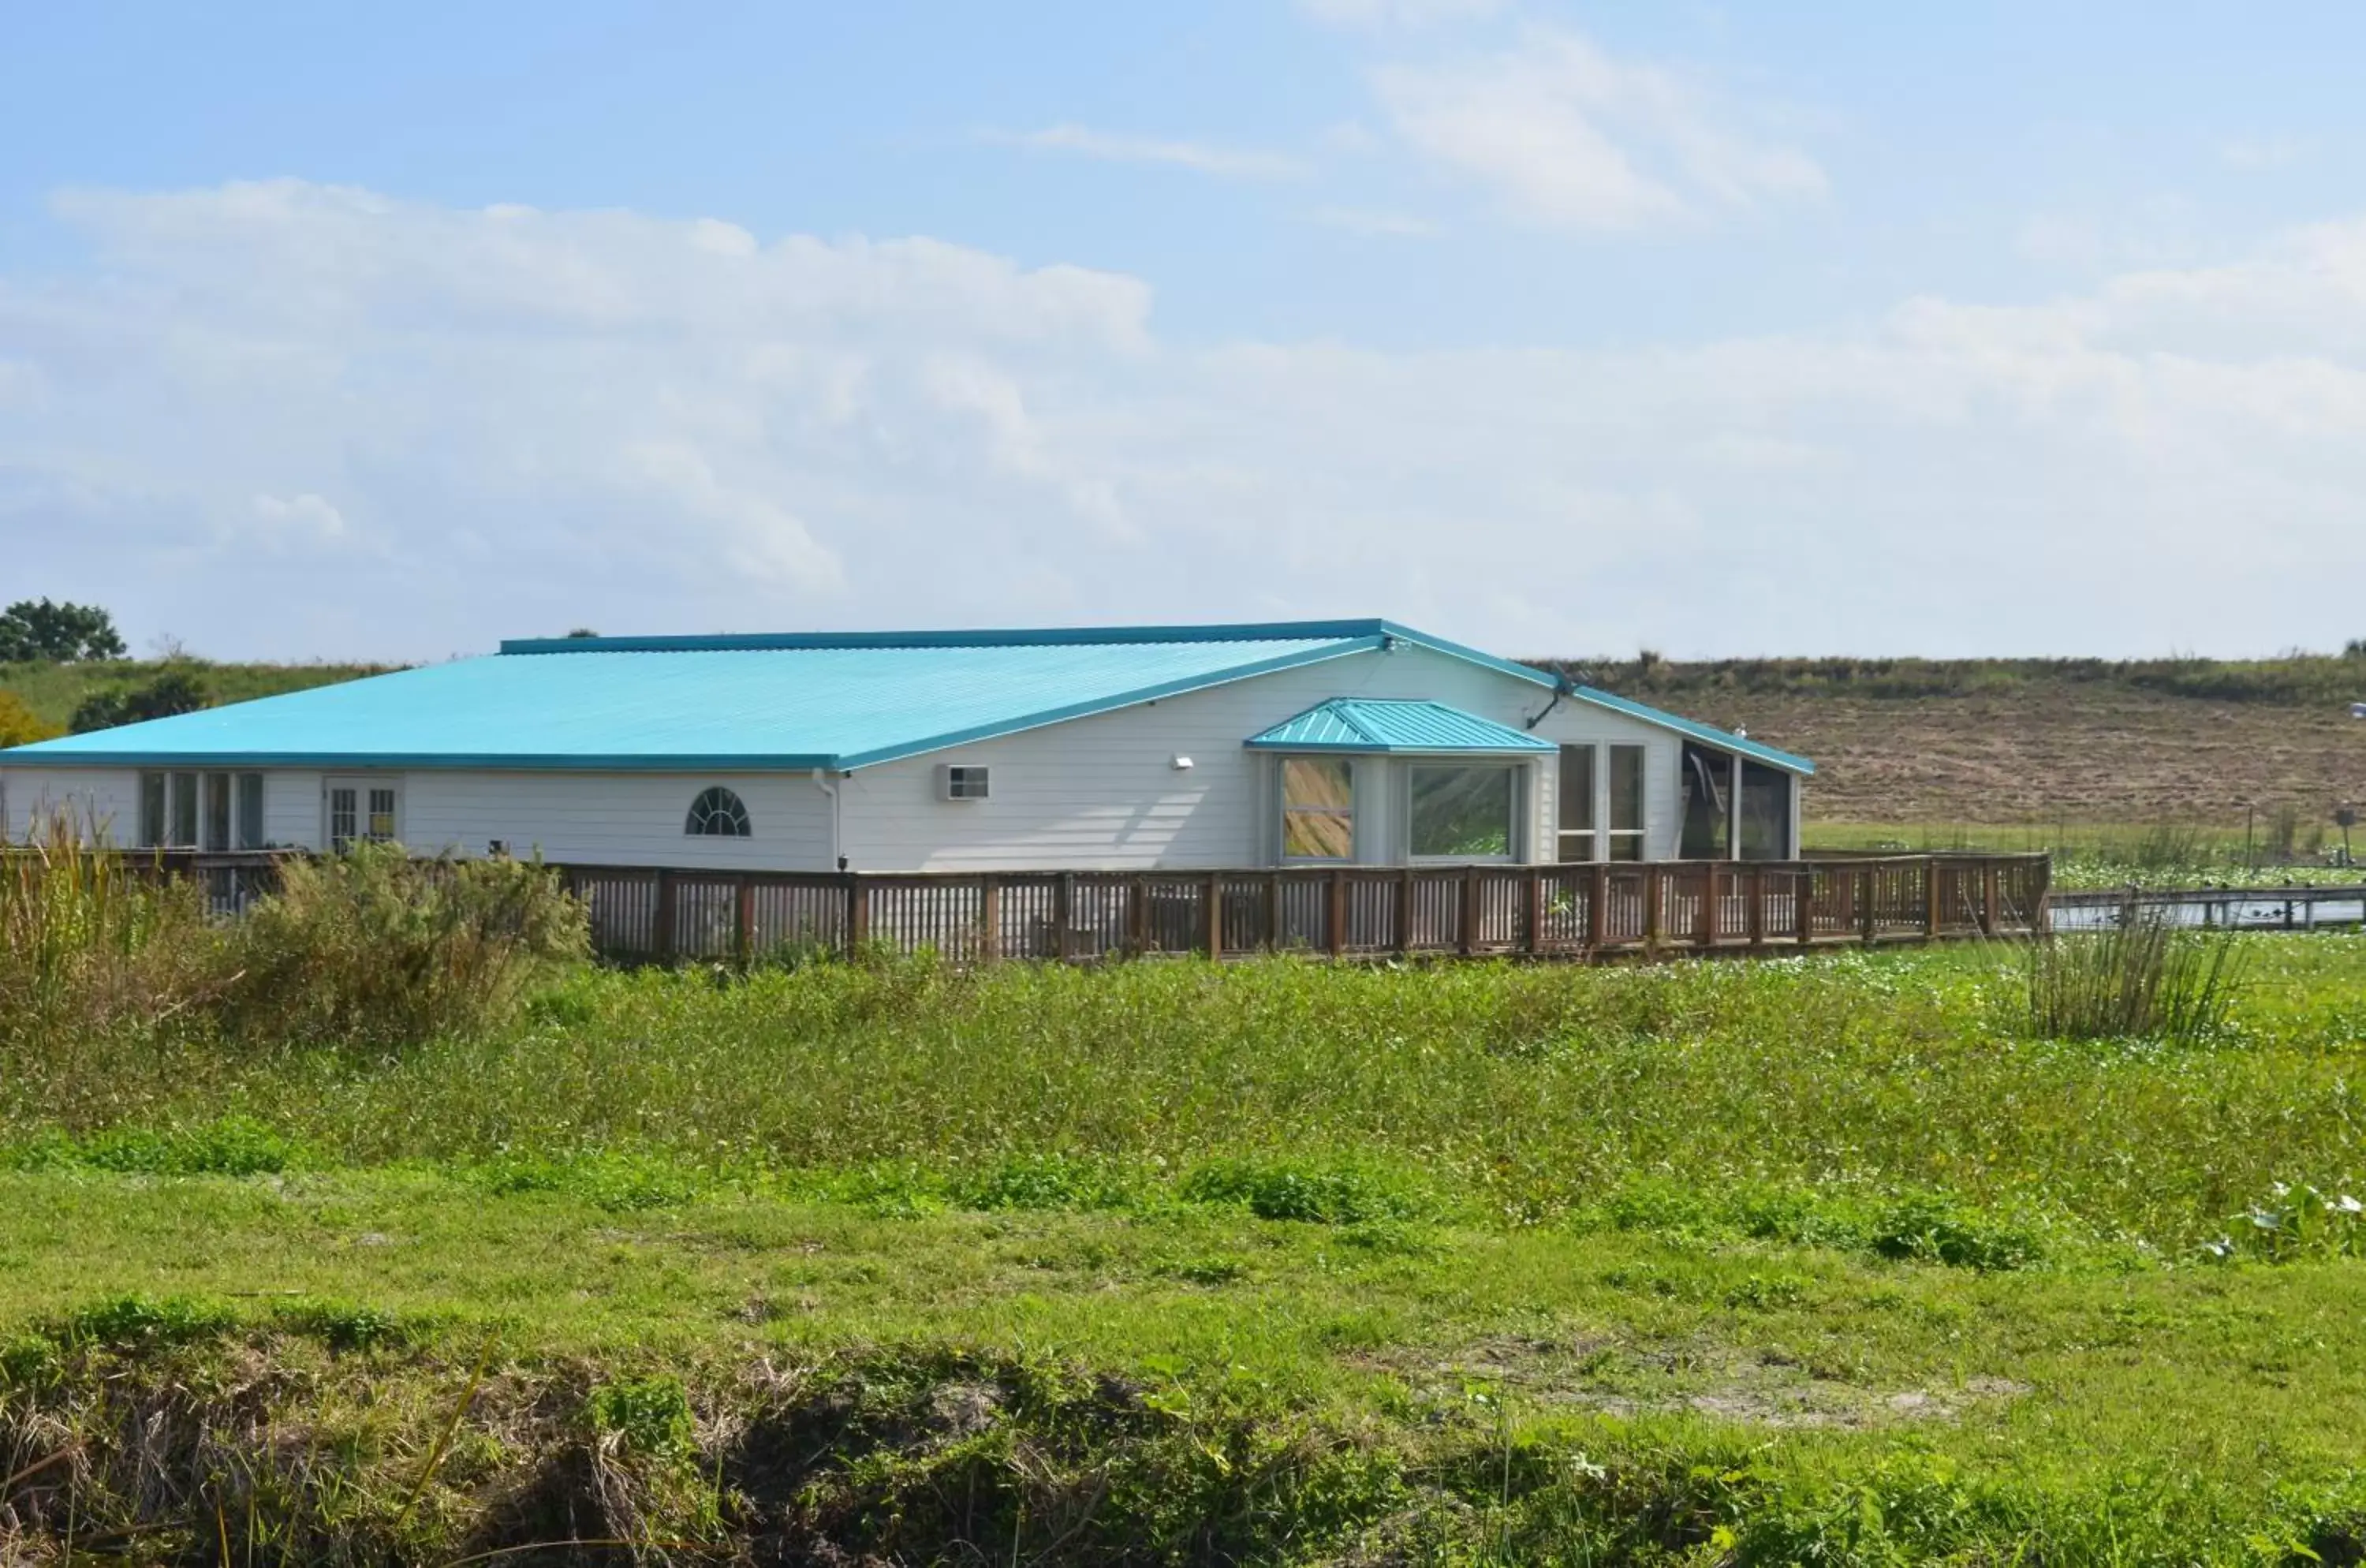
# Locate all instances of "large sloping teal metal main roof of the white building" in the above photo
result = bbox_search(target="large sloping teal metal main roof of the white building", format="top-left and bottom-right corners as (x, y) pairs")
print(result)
(0, 620), (1803, 771)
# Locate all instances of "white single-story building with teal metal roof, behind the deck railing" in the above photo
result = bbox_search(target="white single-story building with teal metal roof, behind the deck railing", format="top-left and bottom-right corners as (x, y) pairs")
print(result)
(0, 620), (1815, 870)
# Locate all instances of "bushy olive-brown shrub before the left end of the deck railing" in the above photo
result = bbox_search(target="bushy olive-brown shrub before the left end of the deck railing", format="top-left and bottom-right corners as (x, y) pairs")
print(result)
(227, 844), (592, 1045)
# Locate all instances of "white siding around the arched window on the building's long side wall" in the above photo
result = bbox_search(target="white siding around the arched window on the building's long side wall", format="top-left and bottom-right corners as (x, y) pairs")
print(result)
(407, 769), (833, 870)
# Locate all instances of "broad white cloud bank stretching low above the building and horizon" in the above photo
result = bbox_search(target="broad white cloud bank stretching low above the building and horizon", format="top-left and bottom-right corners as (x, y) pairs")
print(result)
(0, 185), (2366, 658)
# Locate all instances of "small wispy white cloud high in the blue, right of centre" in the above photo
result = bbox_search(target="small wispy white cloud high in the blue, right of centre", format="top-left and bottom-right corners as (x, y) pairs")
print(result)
(1372, 26), (1824, 230)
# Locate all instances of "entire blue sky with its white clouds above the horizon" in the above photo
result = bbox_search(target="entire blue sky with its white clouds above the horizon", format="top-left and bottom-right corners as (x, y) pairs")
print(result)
(0, 0), (2366, 658)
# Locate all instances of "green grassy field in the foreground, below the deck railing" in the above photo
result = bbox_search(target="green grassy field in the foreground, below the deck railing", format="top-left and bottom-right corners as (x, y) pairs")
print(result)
(13, 936), (2366, 1563)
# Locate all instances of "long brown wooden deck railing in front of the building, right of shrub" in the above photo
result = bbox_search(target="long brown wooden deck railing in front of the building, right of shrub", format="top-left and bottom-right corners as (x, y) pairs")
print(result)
(561, 856), (2049, 962)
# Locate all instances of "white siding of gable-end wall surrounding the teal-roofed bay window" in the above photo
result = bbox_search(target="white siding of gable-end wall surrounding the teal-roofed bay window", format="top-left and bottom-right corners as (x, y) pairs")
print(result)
(842, 648), (1680, 870)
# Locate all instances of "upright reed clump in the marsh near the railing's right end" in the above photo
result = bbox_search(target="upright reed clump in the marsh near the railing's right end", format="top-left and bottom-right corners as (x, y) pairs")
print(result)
(2028, 915), (2243, 1045)
